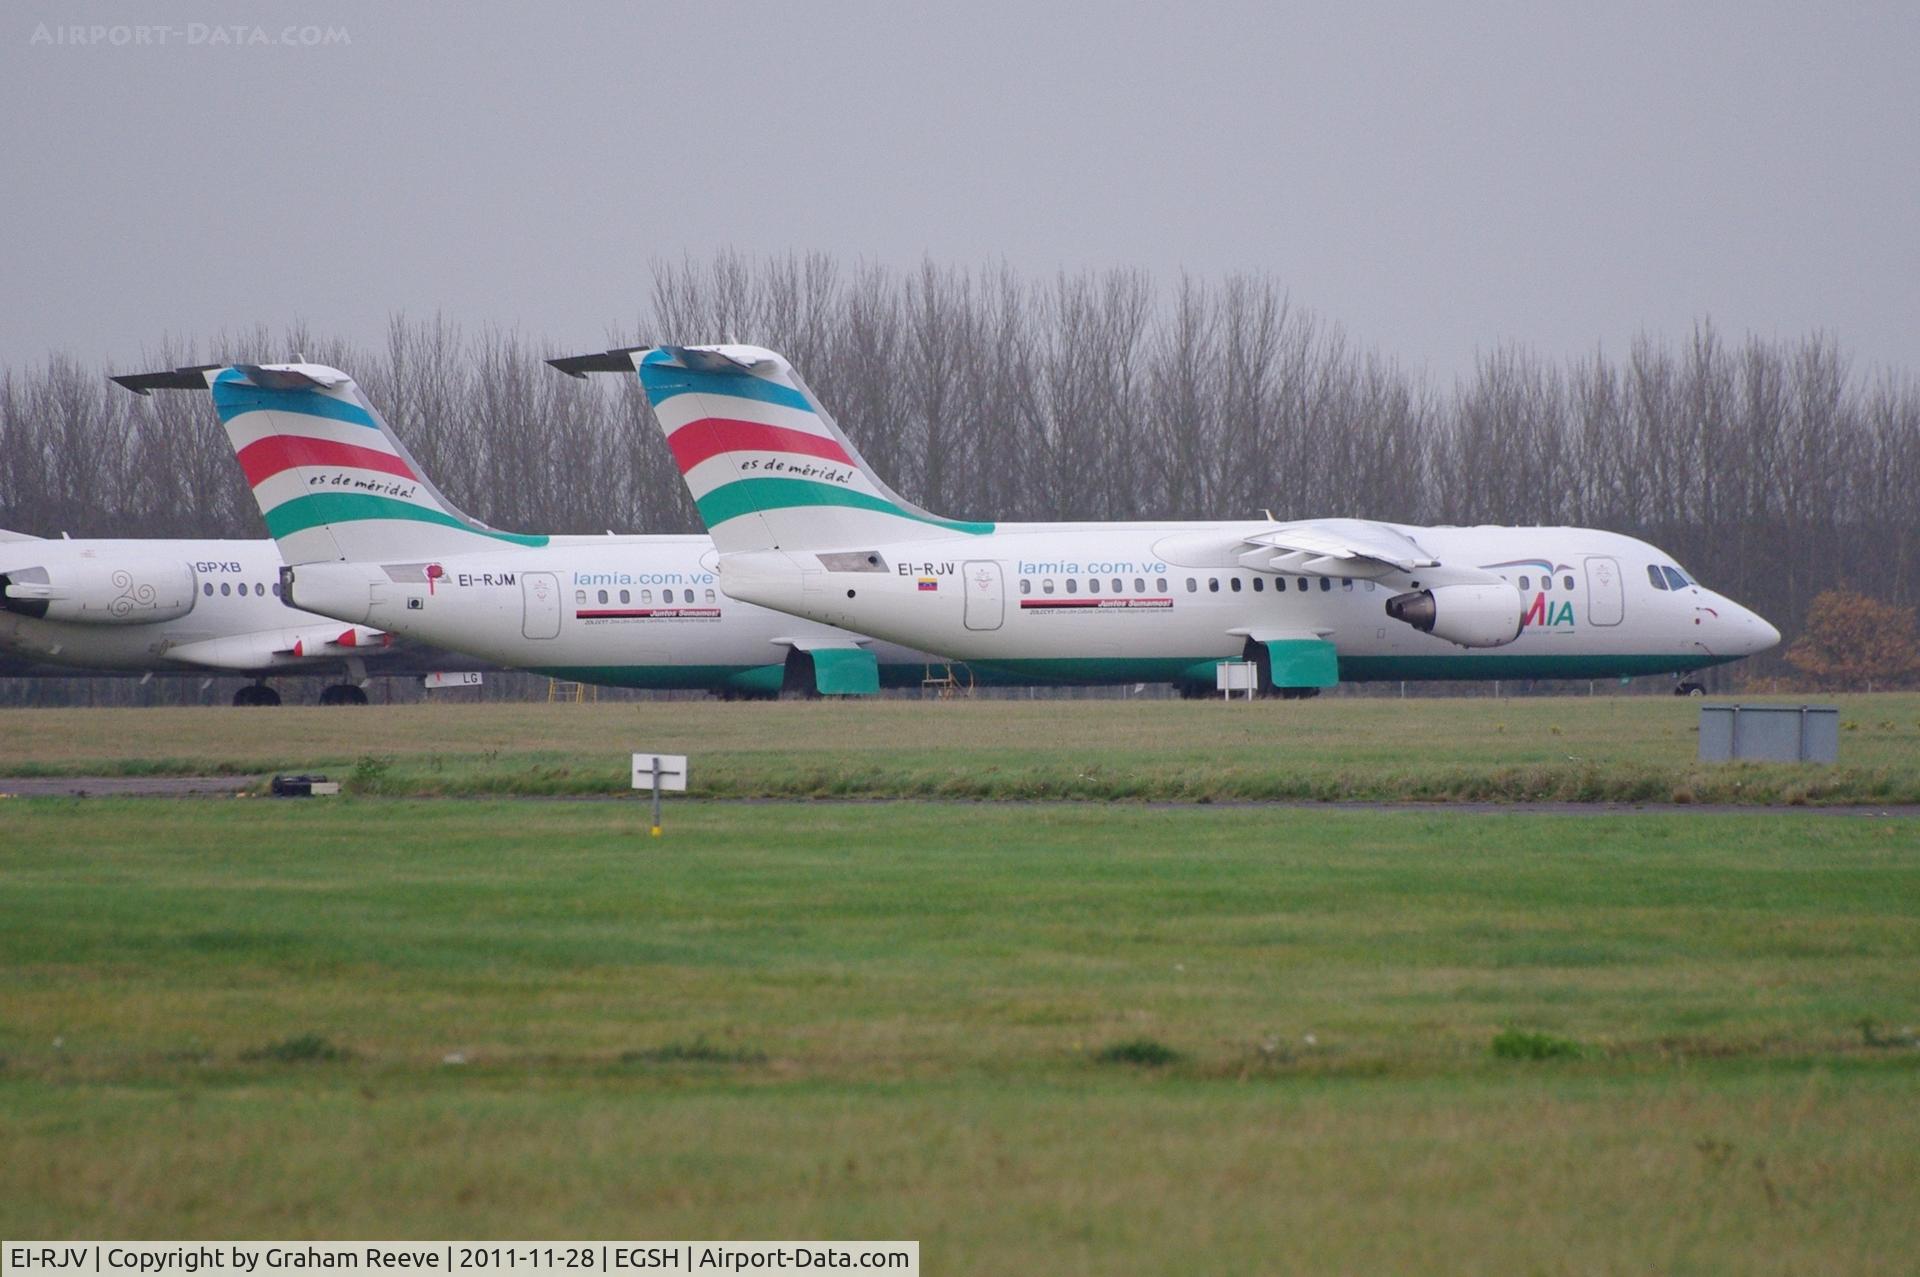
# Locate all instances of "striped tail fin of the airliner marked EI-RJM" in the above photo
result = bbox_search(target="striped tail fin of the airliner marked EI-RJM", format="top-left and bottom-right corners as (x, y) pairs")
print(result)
(113, 363), (547, 563)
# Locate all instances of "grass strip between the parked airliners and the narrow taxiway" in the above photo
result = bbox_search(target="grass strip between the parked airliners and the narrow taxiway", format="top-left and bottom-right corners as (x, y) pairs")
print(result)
(0, 693), (1920, 805)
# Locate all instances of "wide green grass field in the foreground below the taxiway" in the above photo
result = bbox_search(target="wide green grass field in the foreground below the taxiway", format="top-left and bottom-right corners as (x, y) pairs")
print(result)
(0, 798), (1920, 1273)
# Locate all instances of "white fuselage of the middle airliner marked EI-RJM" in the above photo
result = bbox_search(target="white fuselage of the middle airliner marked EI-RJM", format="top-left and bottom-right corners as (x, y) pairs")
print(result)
(290, 536), (937, 691)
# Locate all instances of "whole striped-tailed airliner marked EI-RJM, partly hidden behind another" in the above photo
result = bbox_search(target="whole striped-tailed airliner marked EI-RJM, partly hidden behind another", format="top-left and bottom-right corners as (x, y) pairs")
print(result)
(113, 363), (960, 697)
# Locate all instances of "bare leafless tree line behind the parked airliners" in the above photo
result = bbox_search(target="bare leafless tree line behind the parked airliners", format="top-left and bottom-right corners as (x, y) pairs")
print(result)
(0, 247), (1920, 656)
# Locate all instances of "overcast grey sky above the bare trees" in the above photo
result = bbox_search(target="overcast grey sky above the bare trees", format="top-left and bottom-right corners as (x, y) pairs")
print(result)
(0, 0), (1920, 380)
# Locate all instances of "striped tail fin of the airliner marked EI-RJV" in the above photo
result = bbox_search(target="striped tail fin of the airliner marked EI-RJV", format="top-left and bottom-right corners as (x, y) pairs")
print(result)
(549, 346), (993, 553)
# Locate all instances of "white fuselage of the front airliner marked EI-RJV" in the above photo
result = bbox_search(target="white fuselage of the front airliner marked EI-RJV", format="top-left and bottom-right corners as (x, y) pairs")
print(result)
(720, 522), (1778, 686)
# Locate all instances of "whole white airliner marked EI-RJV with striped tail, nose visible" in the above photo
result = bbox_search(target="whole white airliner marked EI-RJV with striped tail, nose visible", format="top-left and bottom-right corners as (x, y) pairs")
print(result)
(551, 346), (1780, 695)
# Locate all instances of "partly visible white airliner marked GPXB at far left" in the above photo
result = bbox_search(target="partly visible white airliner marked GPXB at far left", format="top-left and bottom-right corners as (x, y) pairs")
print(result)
(0, 532), (399, 705)
